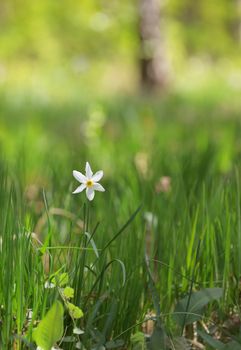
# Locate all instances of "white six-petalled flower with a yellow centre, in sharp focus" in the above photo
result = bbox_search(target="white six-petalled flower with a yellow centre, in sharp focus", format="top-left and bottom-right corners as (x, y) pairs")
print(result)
(73, 162), (105, 201)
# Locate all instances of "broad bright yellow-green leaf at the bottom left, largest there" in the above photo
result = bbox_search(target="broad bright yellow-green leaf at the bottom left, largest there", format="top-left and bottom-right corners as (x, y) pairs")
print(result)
(33, 301), (64, 350)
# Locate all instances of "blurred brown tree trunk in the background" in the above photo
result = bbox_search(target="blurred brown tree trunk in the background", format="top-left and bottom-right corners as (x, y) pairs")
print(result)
(139, 0), (169, 91)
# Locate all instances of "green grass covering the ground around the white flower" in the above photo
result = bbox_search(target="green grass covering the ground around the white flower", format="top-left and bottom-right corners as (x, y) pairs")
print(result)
(0, 91), (241, 349)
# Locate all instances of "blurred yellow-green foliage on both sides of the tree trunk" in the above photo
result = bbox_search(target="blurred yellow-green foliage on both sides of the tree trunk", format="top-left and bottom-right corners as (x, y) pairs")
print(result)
(0, 0), (241, 95)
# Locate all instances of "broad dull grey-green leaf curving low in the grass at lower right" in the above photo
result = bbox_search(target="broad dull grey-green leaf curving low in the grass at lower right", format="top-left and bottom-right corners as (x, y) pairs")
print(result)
(174, 288), (223, 326)
